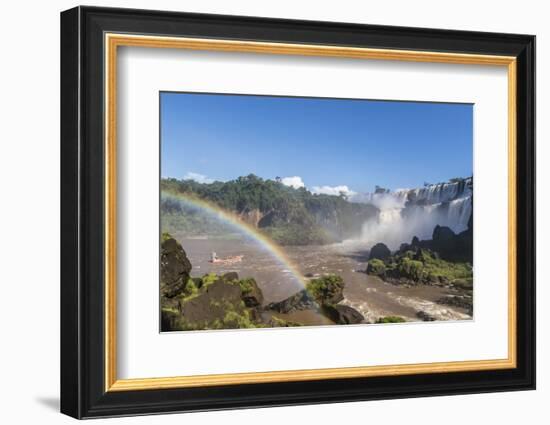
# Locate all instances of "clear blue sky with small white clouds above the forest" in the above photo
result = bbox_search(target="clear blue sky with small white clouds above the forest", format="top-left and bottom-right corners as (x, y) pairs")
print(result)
(161, 93), (473, 193)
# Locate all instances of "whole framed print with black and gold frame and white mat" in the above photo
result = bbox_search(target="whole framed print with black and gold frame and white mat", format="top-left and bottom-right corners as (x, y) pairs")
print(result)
(61, 7), (535, 418)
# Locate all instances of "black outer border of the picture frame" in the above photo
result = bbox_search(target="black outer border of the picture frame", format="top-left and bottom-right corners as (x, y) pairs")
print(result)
(61, 6), (535, 418)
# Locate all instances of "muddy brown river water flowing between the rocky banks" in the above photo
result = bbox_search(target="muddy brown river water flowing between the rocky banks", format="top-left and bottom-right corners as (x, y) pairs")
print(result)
(175, 234), (471, 325)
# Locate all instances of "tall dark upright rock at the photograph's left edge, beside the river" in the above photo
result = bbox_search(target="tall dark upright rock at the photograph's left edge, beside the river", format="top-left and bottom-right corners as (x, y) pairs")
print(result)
(160, 234), (192, 298)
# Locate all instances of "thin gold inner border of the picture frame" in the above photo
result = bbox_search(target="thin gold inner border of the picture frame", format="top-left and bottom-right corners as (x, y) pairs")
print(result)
(105, 33), (517, 391)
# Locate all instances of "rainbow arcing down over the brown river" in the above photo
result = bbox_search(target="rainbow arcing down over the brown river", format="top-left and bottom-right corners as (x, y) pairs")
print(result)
(161, 191), (307, 288)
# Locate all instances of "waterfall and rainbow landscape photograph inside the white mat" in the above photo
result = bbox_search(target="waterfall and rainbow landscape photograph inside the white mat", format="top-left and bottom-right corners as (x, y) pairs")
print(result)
(159, 92), (477, 332)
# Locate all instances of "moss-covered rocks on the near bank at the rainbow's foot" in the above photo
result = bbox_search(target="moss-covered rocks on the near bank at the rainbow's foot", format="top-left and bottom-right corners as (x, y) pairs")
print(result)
(161, 234), (374, 331)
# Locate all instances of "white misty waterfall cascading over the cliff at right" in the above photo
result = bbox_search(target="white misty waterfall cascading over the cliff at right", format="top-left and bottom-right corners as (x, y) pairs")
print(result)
(352, 178), (473, 249)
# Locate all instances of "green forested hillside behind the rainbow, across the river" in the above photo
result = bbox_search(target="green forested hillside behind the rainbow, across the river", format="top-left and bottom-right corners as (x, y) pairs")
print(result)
(161, 174), (379, 245)
